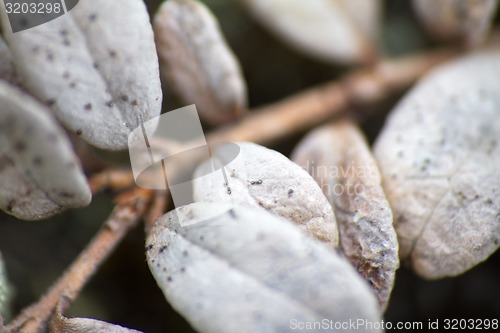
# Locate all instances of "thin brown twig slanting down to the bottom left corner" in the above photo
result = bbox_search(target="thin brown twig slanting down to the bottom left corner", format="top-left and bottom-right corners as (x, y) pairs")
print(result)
(5, 189), (153, 333)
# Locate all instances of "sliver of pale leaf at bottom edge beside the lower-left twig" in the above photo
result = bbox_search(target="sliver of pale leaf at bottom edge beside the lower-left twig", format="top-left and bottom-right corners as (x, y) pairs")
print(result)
(50, 315), (141, 333)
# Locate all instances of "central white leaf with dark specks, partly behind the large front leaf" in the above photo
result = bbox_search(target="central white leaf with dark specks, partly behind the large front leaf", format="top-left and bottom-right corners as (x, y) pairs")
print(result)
(193, 142), (338, 248)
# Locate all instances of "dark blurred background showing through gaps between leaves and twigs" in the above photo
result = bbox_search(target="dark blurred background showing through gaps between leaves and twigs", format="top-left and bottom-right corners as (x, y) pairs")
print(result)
(0, 0), (500, 333)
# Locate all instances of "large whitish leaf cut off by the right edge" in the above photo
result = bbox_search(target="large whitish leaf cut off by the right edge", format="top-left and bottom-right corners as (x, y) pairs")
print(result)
(375, 49), (500, 278)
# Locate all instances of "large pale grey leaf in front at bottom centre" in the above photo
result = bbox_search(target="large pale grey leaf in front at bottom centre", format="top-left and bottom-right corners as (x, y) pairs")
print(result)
(146, 203), (380, 333)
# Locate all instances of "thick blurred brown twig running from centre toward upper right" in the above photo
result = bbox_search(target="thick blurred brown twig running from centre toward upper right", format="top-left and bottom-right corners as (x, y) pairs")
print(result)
(207, 49), (459, 144)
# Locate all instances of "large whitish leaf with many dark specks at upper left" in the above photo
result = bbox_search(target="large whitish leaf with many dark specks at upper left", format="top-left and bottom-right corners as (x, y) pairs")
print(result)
(2, 0), (162, 149)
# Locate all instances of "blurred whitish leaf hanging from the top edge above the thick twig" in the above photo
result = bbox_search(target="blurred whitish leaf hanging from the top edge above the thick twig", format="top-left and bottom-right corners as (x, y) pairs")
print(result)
(241, 0), (380, 64)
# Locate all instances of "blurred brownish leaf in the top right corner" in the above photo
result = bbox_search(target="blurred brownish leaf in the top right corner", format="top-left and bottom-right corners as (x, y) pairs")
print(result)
(413, 0), (498, 46)
